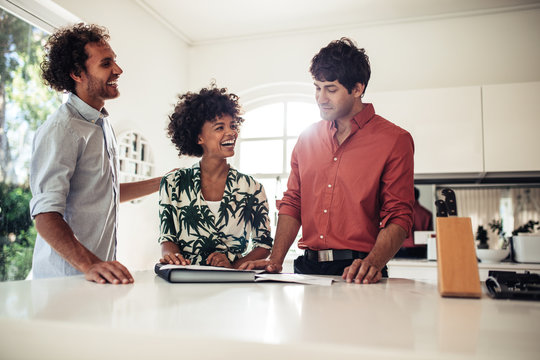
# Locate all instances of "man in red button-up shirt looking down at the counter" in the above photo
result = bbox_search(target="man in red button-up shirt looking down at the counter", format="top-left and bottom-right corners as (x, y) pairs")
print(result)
(242, 38), (414, 283)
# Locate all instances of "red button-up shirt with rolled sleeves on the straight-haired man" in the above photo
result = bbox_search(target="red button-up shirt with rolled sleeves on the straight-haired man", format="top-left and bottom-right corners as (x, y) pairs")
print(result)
(279, 104), (414, 252)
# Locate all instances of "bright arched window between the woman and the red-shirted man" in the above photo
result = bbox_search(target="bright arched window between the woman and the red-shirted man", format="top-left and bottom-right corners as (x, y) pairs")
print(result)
(236, 99), (320, 249)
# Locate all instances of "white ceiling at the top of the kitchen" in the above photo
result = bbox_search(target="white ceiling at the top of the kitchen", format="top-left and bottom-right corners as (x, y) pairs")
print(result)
(135, 0), (540, 45)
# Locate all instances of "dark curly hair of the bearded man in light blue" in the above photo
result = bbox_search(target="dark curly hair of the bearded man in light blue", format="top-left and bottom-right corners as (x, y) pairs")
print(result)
(41, 23), (109, 93)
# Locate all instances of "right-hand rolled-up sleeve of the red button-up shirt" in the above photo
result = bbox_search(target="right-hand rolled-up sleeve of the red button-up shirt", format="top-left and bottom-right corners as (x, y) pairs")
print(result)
(380, 133), (414, 234)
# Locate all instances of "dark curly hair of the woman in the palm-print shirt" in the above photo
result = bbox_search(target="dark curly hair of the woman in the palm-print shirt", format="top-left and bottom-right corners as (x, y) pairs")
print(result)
(167, 84), (244, 157)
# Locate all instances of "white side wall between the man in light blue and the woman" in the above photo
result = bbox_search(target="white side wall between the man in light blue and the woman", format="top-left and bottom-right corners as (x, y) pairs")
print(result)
(51, 0), (193, 270)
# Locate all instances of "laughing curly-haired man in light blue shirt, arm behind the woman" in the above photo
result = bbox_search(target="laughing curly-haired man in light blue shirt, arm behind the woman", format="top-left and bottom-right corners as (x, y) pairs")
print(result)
(30, 23), (168, 284)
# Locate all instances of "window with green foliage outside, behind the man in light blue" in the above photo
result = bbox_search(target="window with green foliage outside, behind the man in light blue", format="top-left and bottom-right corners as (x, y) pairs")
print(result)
(0, 8), (61, 281)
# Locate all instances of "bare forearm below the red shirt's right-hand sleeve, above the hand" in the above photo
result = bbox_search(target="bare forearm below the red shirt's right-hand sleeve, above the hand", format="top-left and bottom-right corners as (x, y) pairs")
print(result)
(366, 224), (407, 269)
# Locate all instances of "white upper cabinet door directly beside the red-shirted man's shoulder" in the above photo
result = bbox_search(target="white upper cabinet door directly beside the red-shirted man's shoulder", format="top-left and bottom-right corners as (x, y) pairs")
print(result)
(365, 87), (484, 174)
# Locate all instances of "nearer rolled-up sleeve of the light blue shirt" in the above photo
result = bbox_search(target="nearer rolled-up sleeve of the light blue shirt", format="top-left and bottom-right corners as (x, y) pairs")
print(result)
(30, 123), (78, 217)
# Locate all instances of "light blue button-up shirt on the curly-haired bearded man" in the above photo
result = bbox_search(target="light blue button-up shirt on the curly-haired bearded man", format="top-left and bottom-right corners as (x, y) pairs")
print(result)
(30, 94), (119, 278)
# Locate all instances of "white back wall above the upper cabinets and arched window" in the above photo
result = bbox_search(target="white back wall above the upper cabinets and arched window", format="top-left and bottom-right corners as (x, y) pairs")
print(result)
(189, 9), (540, 100)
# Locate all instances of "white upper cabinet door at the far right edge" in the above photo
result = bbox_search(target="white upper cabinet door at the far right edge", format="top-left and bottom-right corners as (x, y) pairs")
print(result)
(482, 82), (540, 171)
